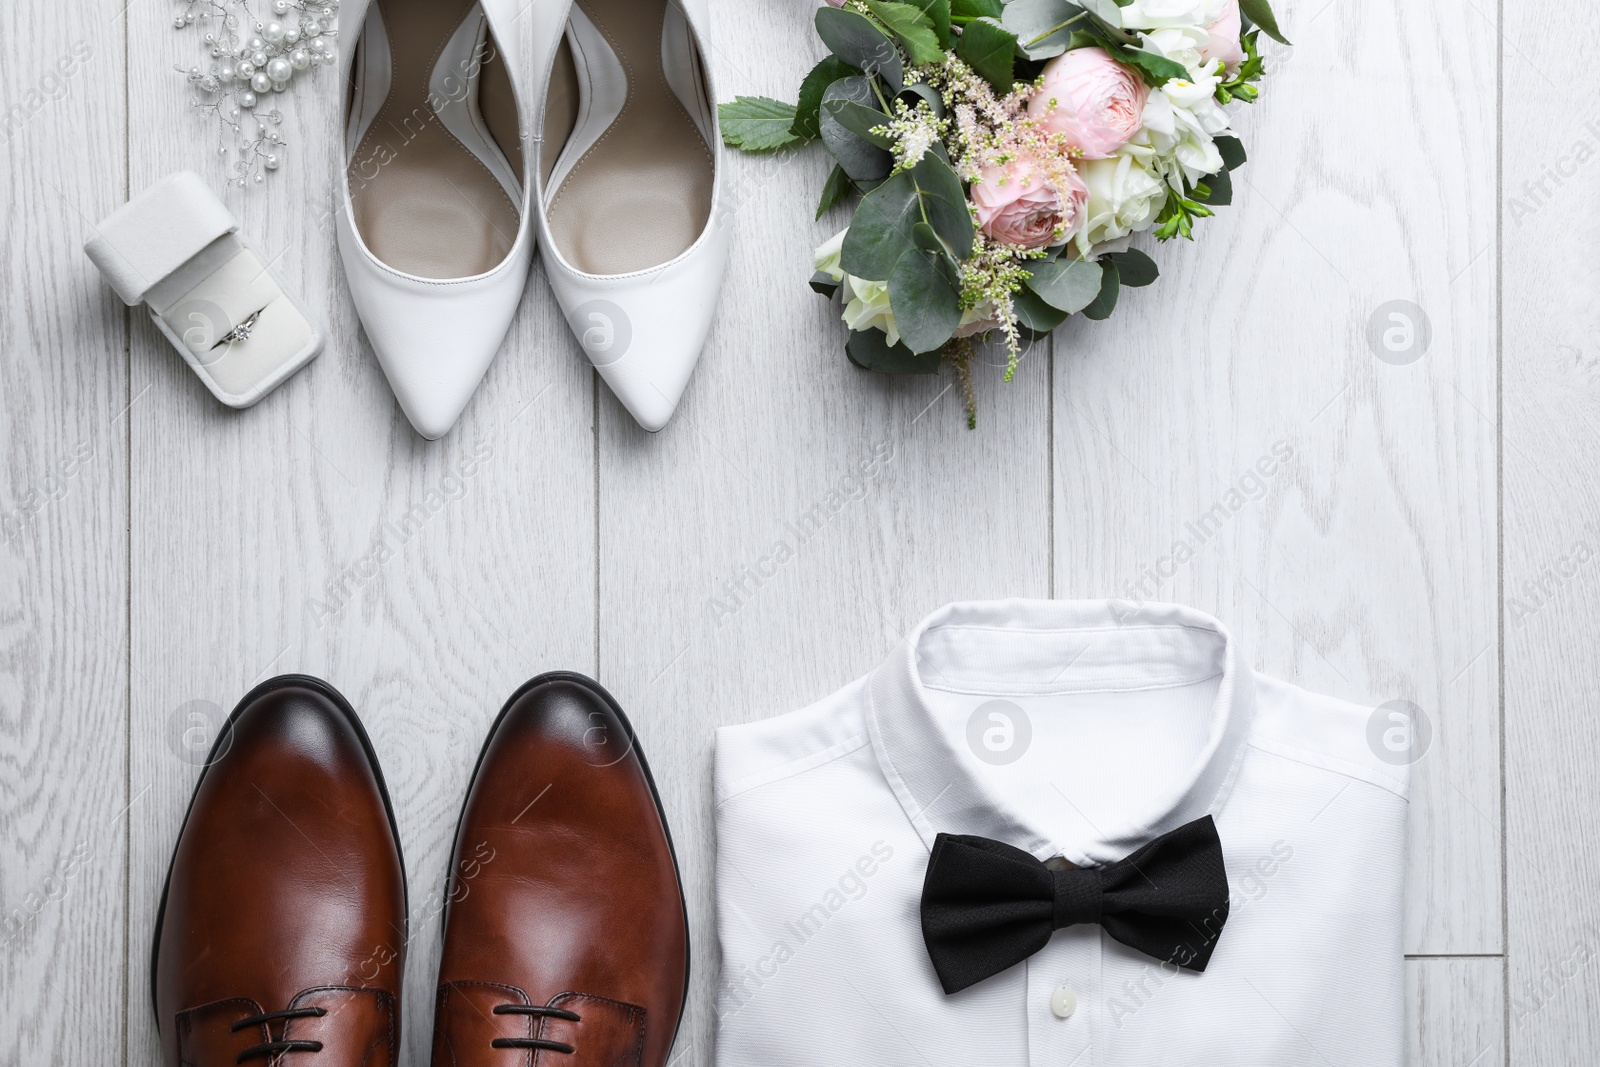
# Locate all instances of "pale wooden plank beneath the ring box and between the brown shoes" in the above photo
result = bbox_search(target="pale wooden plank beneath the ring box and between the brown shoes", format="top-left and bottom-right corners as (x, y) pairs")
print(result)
(118, 8), (595, 1061)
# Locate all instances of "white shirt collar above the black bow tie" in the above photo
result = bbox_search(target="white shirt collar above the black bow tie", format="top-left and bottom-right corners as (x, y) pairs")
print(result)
(867, 600), (1254, 864)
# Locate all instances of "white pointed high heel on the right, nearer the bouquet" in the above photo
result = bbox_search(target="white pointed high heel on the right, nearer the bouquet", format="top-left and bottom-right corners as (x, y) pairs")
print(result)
(530, 0), (728, 432)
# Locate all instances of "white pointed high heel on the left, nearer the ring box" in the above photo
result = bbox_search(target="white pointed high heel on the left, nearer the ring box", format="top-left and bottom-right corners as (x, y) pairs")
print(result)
(338, 0), (533, 440)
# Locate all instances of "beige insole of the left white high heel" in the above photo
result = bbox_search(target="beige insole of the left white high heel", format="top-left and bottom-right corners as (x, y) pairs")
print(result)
(349, 0), (522, 278)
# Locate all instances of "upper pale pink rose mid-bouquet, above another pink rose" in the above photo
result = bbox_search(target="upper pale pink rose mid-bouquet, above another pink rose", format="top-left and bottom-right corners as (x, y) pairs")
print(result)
(1027, 46), (1150, 160)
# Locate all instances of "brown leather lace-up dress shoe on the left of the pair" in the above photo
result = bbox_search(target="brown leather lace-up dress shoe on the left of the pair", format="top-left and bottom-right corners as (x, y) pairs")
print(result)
(150, 677), (406, 1067)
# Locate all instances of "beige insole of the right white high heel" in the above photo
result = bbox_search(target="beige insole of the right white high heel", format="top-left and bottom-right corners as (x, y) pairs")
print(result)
(546, 0), (712, 274)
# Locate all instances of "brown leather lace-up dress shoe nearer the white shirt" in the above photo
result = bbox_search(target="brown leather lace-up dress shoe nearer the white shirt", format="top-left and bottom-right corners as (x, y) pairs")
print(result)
(434, 672), (690, 1067)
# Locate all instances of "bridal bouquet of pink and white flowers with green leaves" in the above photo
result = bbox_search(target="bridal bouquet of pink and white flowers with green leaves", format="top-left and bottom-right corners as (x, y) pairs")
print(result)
(718, 0), (1286, 424)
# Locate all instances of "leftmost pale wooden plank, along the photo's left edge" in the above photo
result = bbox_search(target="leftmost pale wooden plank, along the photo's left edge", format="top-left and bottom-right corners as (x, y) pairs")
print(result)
(0, 0), (138, 1064)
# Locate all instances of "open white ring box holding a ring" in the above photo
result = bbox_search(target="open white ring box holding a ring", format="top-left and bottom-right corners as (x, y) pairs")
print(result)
(83, 171), (322, 408)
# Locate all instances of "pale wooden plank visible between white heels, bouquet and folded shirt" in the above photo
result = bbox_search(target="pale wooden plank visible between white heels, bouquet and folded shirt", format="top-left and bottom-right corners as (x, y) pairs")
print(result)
(600, 0), (1050, 1065)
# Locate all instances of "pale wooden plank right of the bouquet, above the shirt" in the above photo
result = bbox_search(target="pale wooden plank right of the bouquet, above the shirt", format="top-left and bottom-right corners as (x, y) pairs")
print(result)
(1054, 0), (1501, 953)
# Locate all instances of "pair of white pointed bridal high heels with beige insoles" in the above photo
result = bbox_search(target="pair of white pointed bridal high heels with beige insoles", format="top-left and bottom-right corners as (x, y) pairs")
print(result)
(338, 0), (728, 440)
